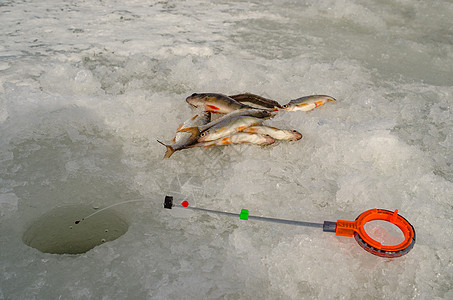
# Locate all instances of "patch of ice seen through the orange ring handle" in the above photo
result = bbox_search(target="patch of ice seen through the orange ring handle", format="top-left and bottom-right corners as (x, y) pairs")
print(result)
(364, 220), (404, 246)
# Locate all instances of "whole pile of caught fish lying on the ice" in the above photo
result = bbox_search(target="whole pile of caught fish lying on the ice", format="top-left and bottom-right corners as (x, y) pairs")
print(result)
(158, 93), (335, 158)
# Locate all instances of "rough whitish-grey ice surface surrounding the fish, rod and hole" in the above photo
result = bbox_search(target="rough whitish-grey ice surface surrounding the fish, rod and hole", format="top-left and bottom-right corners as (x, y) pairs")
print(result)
(0, 0), (453, 299)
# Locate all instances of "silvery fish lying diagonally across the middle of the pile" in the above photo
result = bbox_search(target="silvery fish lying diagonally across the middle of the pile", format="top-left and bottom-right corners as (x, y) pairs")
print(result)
(198, 116), (264, 143)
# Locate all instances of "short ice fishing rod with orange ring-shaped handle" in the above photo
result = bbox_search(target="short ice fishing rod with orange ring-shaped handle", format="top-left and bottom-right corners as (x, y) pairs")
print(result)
(164, 196), (415, 258)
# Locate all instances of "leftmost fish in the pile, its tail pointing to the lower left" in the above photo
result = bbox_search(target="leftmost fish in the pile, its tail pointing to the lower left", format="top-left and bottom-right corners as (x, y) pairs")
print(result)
(158, 111), (211, 159)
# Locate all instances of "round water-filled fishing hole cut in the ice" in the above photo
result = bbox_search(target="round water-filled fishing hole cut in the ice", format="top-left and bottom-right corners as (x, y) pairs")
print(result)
(22, 205), (129, 254)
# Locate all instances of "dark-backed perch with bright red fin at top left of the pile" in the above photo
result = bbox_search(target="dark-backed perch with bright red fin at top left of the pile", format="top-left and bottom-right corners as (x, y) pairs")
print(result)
(186, 93), (253, 114)
